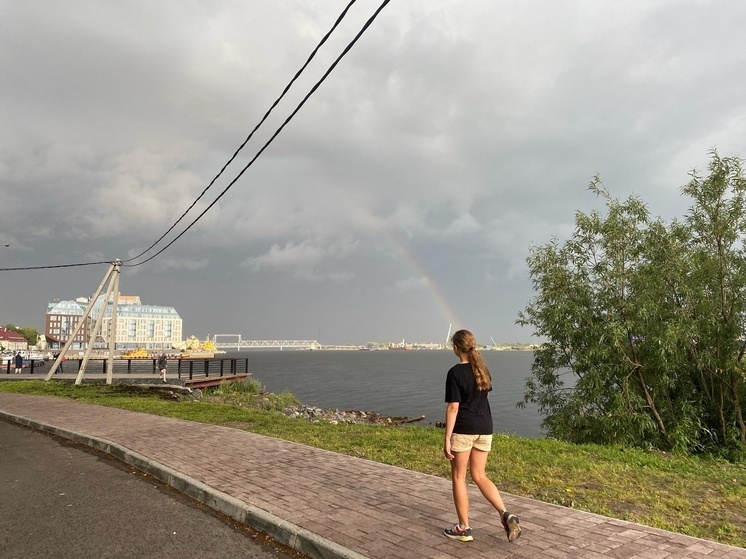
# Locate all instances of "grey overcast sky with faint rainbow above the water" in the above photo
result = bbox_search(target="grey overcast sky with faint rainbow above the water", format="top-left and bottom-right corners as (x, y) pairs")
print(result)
(0, 0), (746, 343)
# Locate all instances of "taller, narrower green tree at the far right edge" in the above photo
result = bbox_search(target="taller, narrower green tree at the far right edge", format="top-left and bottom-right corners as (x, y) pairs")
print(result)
(682, 154), (746, 450)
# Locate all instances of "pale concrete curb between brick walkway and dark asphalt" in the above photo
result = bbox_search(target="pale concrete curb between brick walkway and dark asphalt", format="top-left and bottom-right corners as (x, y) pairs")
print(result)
(0, 410), (368, 559)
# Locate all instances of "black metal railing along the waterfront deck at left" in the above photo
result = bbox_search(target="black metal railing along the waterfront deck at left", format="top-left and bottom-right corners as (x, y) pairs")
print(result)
(3, 357), (249, 379)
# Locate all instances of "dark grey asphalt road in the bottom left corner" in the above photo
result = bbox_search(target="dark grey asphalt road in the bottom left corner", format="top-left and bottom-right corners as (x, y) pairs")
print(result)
(0, 420), (303, 559)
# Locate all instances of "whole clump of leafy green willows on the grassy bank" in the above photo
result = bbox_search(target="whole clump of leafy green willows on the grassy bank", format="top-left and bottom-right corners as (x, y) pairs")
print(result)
(518, 152), (746, 458)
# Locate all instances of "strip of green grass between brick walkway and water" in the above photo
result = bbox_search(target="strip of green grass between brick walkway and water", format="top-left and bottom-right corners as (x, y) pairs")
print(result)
(0, 381), (746, 548)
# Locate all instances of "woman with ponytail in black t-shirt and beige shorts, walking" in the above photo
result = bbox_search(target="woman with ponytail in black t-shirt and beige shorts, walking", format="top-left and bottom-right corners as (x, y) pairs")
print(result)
(443, 330), (521, 542)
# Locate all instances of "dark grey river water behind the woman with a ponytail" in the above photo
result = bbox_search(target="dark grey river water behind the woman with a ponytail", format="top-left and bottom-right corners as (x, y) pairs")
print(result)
(232, 350), (543, 438)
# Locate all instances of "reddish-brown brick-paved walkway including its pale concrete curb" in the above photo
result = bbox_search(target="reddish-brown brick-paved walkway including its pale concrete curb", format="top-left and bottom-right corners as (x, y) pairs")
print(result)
(0, 393), (746, 559)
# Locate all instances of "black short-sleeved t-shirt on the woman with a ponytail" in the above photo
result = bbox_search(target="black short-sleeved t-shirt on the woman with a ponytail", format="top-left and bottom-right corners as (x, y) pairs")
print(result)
(446, 363), (492, 435)
